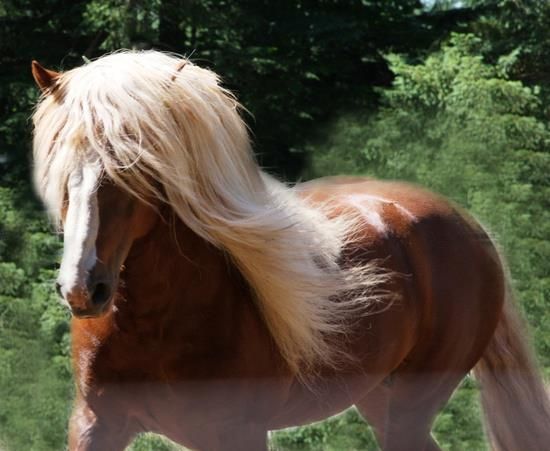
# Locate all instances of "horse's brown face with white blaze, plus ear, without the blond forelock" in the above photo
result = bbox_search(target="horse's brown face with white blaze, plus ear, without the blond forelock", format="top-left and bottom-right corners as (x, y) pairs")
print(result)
(33, 62), (158, 317)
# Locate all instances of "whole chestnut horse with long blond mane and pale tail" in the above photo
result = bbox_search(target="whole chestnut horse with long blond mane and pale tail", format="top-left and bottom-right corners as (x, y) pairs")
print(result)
(32, 51), (550, 451)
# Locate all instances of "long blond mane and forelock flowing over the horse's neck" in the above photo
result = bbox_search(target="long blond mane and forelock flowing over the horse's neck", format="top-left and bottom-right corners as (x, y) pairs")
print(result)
(34, 51), (388, 375)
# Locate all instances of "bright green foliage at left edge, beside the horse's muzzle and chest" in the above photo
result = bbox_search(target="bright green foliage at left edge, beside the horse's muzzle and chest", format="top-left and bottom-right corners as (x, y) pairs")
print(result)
(0, 188), (72, 451)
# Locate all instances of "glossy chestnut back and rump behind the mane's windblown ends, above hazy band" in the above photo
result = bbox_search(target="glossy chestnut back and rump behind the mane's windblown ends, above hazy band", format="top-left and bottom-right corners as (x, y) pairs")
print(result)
(298, 178), (504, 384)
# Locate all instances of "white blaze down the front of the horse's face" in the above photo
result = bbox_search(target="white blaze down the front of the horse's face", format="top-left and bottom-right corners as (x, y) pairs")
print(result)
(57, 164), (99, 299)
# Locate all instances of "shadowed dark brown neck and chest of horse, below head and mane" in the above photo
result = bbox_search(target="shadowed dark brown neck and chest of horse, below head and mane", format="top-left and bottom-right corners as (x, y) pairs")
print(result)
(102, 212), (287, 379)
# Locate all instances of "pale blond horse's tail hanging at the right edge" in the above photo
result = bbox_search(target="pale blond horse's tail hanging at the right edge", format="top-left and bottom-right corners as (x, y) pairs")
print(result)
(474, 283), (550, 451)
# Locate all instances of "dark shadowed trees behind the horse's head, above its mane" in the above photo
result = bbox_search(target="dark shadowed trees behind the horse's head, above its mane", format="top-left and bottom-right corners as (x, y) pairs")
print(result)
(0, 0), (472, 178)
